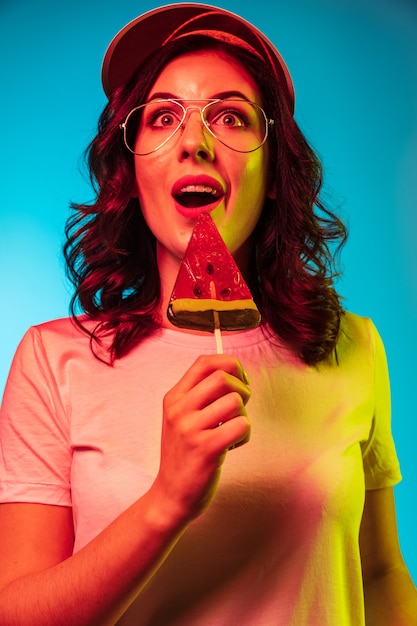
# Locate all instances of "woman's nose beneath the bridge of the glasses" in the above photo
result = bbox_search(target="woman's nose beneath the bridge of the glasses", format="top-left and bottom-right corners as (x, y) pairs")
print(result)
(179, 107), (214, 161)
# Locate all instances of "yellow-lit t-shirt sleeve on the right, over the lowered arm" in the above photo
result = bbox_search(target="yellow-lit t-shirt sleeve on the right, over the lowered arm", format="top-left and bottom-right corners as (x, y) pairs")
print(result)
(362, 321), (401, 489)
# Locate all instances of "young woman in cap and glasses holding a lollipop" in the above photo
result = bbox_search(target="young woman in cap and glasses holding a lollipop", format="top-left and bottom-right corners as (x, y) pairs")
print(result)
(0, 4), (417, 626)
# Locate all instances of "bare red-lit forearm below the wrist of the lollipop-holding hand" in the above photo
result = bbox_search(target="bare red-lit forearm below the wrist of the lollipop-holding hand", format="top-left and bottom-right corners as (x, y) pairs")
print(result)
(0, 492), (185, 626)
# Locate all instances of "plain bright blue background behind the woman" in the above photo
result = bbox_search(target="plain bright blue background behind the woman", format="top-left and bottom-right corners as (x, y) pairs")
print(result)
(0, 0), (417, 580)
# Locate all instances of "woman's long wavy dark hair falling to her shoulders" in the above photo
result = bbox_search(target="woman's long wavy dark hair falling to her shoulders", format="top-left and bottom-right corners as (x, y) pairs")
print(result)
(64, 35), (347, 365)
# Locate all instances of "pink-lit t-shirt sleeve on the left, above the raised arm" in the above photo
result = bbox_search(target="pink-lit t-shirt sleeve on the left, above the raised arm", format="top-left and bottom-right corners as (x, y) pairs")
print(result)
(0, 327), (72, 506)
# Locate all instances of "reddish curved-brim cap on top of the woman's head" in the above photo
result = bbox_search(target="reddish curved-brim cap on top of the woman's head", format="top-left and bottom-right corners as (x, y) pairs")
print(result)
(102, 3), (294, 109)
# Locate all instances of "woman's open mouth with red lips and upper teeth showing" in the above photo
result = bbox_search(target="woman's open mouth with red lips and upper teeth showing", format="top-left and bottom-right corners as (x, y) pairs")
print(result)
(172, 175), (225, 215)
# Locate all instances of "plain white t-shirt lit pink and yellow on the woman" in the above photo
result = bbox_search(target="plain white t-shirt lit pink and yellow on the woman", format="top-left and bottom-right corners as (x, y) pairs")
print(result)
(0, 314), (401, 626)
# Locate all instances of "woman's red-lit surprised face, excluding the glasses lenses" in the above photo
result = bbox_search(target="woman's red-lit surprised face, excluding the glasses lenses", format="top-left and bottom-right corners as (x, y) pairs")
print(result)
(135, 51), (268, 271)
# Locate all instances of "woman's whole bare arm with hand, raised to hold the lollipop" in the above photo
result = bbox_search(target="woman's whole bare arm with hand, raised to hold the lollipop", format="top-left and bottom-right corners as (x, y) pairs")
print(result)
(0, 355), (250, 626)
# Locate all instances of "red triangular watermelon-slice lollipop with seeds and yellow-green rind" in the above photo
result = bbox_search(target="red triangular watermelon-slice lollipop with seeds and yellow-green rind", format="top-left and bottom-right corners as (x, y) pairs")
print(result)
(167, 213), (261, 333)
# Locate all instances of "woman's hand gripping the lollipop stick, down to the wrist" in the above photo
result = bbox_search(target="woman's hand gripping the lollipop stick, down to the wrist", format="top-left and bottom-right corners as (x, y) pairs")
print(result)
(152, 354), (250, 521)
